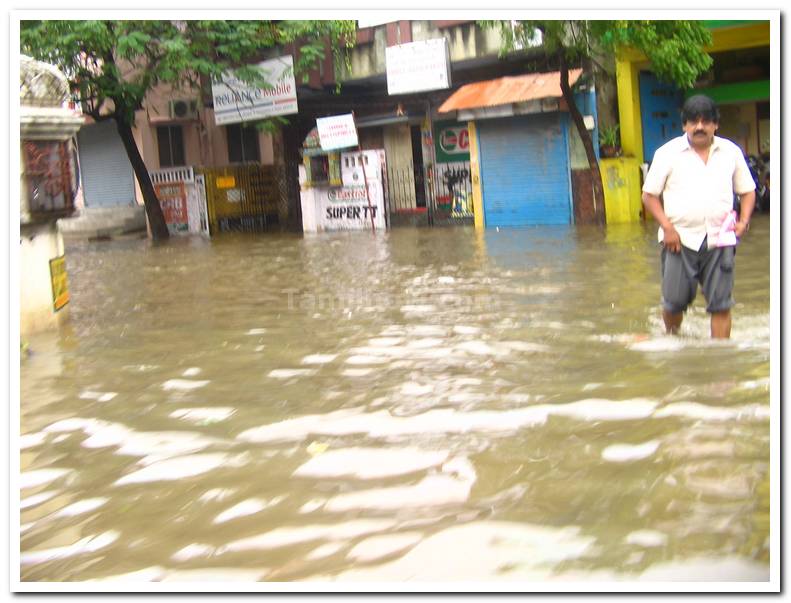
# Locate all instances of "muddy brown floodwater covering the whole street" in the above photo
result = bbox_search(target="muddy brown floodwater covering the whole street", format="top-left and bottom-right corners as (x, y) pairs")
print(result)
(19, 215), (777, 583)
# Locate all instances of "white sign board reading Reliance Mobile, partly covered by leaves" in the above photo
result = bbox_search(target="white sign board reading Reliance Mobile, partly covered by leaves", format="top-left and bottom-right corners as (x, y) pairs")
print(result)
(211, 55), (299, 126)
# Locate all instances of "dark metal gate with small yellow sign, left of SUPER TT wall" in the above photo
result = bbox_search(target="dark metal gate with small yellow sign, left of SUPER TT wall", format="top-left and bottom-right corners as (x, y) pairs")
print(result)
(196, 165), (288, 232)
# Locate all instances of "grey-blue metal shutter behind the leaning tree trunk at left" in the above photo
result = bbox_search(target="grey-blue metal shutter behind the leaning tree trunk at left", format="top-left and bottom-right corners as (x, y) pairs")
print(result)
(77, 120), (137, 207)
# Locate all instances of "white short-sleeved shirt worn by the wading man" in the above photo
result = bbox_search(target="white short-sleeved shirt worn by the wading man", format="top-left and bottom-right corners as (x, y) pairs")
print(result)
(643, 134), (755, 251)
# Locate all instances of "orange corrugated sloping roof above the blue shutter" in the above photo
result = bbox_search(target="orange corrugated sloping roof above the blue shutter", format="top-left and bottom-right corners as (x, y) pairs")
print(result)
(439, 69), (582, 113)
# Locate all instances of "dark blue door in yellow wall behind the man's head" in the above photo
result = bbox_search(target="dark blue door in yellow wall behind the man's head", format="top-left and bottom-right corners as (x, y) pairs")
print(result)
(640, 71), (684, 163)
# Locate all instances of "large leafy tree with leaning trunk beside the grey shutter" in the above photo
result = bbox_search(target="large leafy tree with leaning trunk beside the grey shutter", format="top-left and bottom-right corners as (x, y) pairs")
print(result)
(20, 20), (355, 239)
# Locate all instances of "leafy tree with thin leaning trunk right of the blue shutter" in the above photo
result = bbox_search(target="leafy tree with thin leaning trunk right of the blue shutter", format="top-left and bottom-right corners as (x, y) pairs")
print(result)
(481, 20), (712, 224)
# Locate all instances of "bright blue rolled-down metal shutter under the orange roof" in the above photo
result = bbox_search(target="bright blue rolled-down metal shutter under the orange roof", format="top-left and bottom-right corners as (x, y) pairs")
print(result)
(478, 113), (573, 227)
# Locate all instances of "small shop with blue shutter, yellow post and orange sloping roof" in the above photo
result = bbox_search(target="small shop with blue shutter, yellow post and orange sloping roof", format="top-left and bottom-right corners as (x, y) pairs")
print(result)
(439, 69), (582, 228)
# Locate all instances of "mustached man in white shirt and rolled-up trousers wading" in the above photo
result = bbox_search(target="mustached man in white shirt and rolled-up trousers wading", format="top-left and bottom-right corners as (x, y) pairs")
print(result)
(643, 95), (755, 338)
